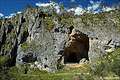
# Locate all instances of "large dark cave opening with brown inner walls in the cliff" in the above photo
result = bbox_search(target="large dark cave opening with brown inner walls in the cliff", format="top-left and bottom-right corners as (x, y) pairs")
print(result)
(64, 31), (89, 64)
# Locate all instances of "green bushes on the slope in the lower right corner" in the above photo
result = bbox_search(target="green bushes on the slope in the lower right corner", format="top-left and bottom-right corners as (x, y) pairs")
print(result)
(92, 49), (120, 77)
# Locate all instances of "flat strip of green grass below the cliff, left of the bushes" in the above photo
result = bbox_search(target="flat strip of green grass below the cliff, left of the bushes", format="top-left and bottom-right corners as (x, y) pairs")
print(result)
(9, 67), (92, 80)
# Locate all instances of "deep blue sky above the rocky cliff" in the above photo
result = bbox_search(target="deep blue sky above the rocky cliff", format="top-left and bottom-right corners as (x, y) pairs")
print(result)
(0, 0), (120, 16)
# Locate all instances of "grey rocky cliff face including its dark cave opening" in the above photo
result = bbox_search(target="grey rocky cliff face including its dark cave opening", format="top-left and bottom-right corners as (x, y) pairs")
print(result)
(0, 8), (120, 71)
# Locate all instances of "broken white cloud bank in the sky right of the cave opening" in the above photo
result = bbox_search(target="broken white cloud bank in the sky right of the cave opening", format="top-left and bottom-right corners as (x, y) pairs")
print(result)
(67, 0), (115, 15)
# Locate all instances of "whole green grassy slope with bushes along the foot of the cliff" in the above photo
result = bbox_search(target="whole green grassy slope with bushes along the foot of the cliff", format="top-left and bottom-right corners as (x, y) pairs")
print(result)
(1, 48), (120, 80)
